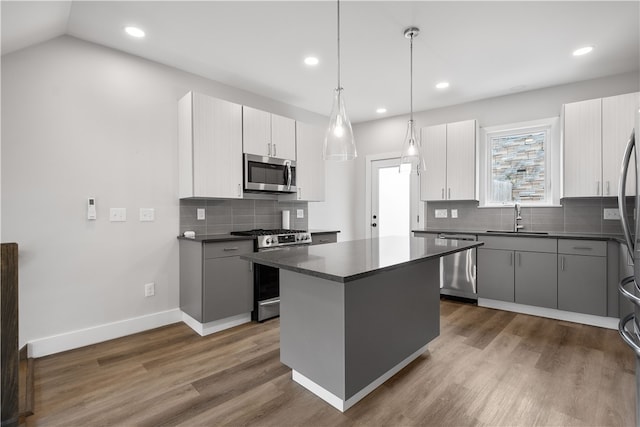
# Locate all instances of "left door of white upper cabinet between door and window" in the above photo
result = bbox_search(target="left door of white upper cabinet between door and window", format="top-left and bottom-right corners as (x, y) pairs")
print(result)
(420, 124), (447, 201)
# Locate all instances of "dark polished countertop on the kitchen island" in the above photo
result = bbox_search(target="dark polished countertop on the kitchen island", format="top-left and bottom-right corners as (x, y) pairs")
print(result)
(240, 236), (483, 283)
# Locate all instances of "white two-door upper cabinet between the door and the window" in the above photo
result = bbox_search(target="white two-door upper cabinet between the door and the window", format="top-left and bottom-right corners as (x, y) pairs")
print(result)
(420, 120), (477, 201)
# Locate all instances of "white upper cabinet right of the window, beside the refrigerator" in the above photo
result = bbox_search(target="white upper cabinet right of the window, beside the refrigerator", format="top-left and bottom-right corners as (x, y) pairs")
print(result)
(564, 93), (640, 197)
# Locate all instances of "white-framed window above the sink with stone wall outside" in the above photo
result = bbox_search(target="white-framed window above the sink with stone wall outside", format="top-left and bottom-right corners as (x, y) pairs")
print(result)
(481, 118), (560, 206)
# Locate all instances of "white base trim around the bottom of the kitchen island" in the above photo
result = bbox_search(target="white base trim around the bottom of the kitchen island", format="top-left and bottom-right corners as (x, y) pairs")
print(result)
(291, 345), (427, 412)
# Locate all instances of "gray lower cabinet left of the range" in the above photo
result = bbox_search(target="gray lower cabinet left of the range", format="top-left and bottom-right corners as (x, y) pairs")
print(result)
(180, 240), (253, 323)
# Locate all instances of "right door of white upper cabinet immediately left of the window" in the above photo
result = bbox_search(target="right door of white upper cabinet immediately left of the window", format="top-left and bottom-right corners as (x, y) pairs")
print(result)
(447, 120), (476, 200)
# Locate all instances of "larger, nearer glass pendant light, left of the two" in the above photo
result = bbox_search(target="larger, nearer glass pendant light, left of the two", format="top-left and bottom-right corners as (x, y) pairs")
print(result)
(323, 0), (358, 160)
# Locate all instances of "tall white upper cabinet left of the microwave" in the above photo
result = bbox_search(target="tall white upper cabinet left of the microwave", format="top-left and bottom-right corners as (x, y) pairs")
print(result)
(178, 92), (242, 199)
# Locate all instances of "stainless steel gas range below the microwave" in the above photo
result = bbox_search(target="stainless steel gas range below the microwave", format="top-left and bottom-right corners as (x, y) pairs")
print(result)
(231, 229), (311, 322)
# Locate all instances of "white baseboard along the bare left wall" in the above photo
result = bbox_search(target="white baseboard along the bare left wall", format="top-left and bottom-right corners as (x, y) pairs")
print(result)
(27, 308), (182, 357)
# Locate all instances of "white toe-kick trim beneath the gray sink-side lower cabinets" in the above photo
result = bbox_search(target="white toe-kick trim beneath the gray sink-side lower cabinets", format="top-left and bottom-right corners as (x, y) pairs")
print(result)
(478, 298), (620, 330)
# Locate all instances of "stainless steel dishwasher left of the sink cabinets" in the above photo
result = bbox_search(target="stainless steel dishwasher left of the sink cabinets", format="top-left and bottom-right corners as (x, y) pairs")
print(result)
(438, 233), (478, 301)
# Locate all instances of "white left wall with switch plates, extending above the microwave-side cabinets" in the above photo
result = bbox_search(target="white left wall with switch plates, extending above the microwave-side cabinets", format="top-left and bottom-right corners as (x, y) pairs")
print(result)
(1, 36), (326, 352)
